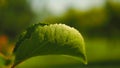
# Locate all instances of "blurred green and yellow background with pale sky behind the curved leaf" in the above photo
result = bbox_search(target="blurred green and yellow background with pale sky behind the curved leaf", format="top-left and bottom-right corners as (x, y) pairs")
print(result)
(0, 0), (120, 68)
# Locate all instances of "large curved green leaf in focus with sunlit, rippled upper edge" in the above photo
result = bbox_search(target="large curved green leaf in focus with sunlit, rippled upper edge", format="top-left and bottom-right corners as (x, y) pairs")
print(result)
(14, 23), (87, 66)
